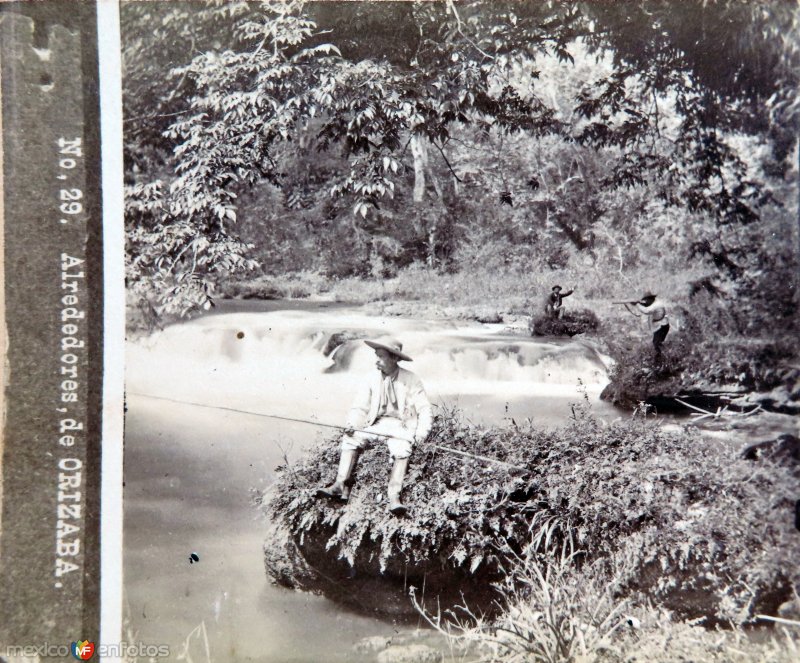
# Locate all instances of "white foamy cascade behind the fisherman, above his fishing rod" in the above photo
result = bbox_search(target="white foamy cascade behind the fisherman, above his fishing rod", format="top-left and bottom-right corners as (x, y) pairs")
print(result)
(127, 310), (607, 423)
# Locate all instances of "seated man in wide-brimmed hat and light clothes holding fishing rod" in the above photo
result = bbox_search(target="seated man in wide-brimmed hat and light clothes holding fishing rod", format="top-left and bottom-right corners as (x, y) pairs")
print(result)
(317, 337), (433, 515)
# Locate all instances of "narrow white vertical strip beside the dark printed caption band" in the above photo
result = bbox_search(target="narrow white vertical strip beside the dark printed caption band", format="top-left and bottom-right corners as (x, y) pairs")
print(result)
(97, 0), (125, 660)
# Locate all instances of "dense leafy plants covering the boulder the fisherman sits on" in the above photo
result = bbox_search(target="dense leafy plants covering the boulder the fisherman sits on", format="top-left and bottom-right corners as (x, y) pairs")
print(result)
(264, 405), (800, 622)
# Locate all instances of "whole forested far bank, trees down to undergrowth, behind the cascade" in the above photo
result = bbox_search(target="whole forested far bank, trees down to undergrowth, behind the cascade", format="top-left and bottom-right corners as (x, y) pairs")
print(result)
(122, 0), (800, 404)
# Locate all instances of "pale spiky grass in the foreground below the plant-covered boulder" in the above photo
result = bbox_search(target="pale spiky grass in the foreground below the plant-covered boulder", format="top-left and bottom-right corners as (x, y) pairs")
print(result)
(412, 520), (800, 663)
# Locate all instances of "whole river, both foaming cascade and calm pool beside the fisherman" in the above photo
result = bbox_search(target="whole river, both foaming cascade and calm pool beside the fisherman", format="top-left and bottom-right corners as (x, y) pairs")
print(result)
(124, 303), (632, 663)
